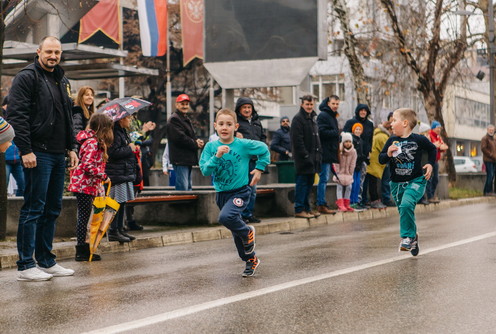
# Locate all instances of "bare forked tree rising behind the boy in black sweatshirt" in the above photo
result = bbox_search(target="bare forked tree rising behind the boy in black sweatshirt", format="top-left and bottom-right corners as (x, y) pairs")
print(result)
(380, 0), (467, 181)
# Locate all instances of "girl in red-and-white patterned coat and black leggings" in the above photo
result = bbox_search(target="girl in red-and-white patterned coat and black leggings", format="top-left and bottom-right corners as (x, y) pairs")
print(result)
(68, 114), (114, 261)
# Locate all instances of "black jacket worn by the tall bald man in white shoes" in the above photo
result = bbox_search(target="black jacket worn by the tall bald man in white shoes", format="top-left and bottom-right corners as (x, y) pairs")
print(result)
(7, 57), (76, 155)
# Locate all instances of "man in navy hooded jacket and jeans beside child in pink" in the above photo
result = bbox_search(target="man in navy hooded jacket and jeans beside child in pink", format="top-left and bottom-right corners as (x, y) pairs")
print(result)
(317, 95), (339, 214)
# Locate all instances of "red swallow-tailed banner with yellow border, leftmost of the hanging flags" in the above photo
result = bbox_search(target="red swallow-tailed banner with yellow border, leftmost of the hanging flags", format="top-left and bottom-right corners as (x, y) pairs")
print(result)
(79, 0), (122, 44)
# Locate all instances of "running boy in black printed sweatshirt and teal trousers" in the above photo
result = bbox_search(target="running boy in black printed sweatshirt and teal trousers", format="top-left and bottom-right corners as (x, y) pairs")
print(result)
(379, 108), (436, 256)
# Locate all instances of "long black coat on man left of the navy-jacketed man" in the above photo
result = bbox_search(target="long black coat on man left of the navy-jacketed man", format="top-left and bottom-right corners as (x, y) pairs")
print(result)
(290, 108), (322, 175)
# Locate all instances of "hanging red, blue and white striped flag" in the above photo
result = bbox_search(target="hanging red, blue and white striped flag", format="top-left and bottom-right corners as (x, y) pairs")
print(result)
(138, 0), (168, 57)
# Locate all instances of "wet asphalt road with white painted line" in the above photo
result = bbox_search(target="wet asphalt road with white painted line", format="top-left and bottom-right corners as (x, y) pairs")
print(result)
(0, 204), (496, 333)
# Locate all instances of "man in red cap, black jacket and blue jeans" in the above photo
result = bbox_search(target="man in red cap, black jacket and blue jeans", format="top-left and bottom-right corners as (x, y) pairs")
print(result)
(167, 94), (204, 190)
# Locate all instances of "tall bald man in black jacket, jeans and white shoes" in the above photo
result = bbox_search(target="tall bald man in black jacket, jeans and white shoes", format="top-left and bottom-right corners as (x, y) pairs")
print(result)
(7, 36), (78, 281)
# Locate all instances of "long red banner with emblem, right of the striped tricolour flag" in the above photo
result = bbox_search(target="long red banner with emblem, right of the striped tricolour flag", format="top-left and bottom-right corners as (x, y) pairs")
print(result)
(181, 0), (204, 66)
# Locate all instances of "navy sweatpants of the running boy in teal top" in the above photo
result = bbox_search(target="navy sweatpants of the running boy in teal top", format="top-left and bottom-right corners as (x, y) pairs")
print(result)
(216, 185), (255, 261)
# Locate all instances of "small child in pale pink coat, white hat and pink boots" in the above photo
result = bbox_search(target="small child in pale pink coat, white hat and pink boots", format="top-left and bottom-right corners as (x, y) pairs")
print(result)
(333, 132), (357, 211)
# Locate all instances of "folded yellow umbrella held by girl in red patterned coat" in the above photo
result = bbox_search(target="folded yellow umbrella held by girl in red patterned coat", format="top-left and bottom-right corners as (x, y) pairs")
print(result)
(88, 181), (120, 261)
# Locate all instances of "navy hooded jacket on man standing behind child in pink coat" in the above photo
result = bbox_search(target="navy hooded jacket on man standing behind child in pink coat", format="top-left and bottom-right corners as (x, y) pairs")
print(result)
(317, 97), (340, 163)
